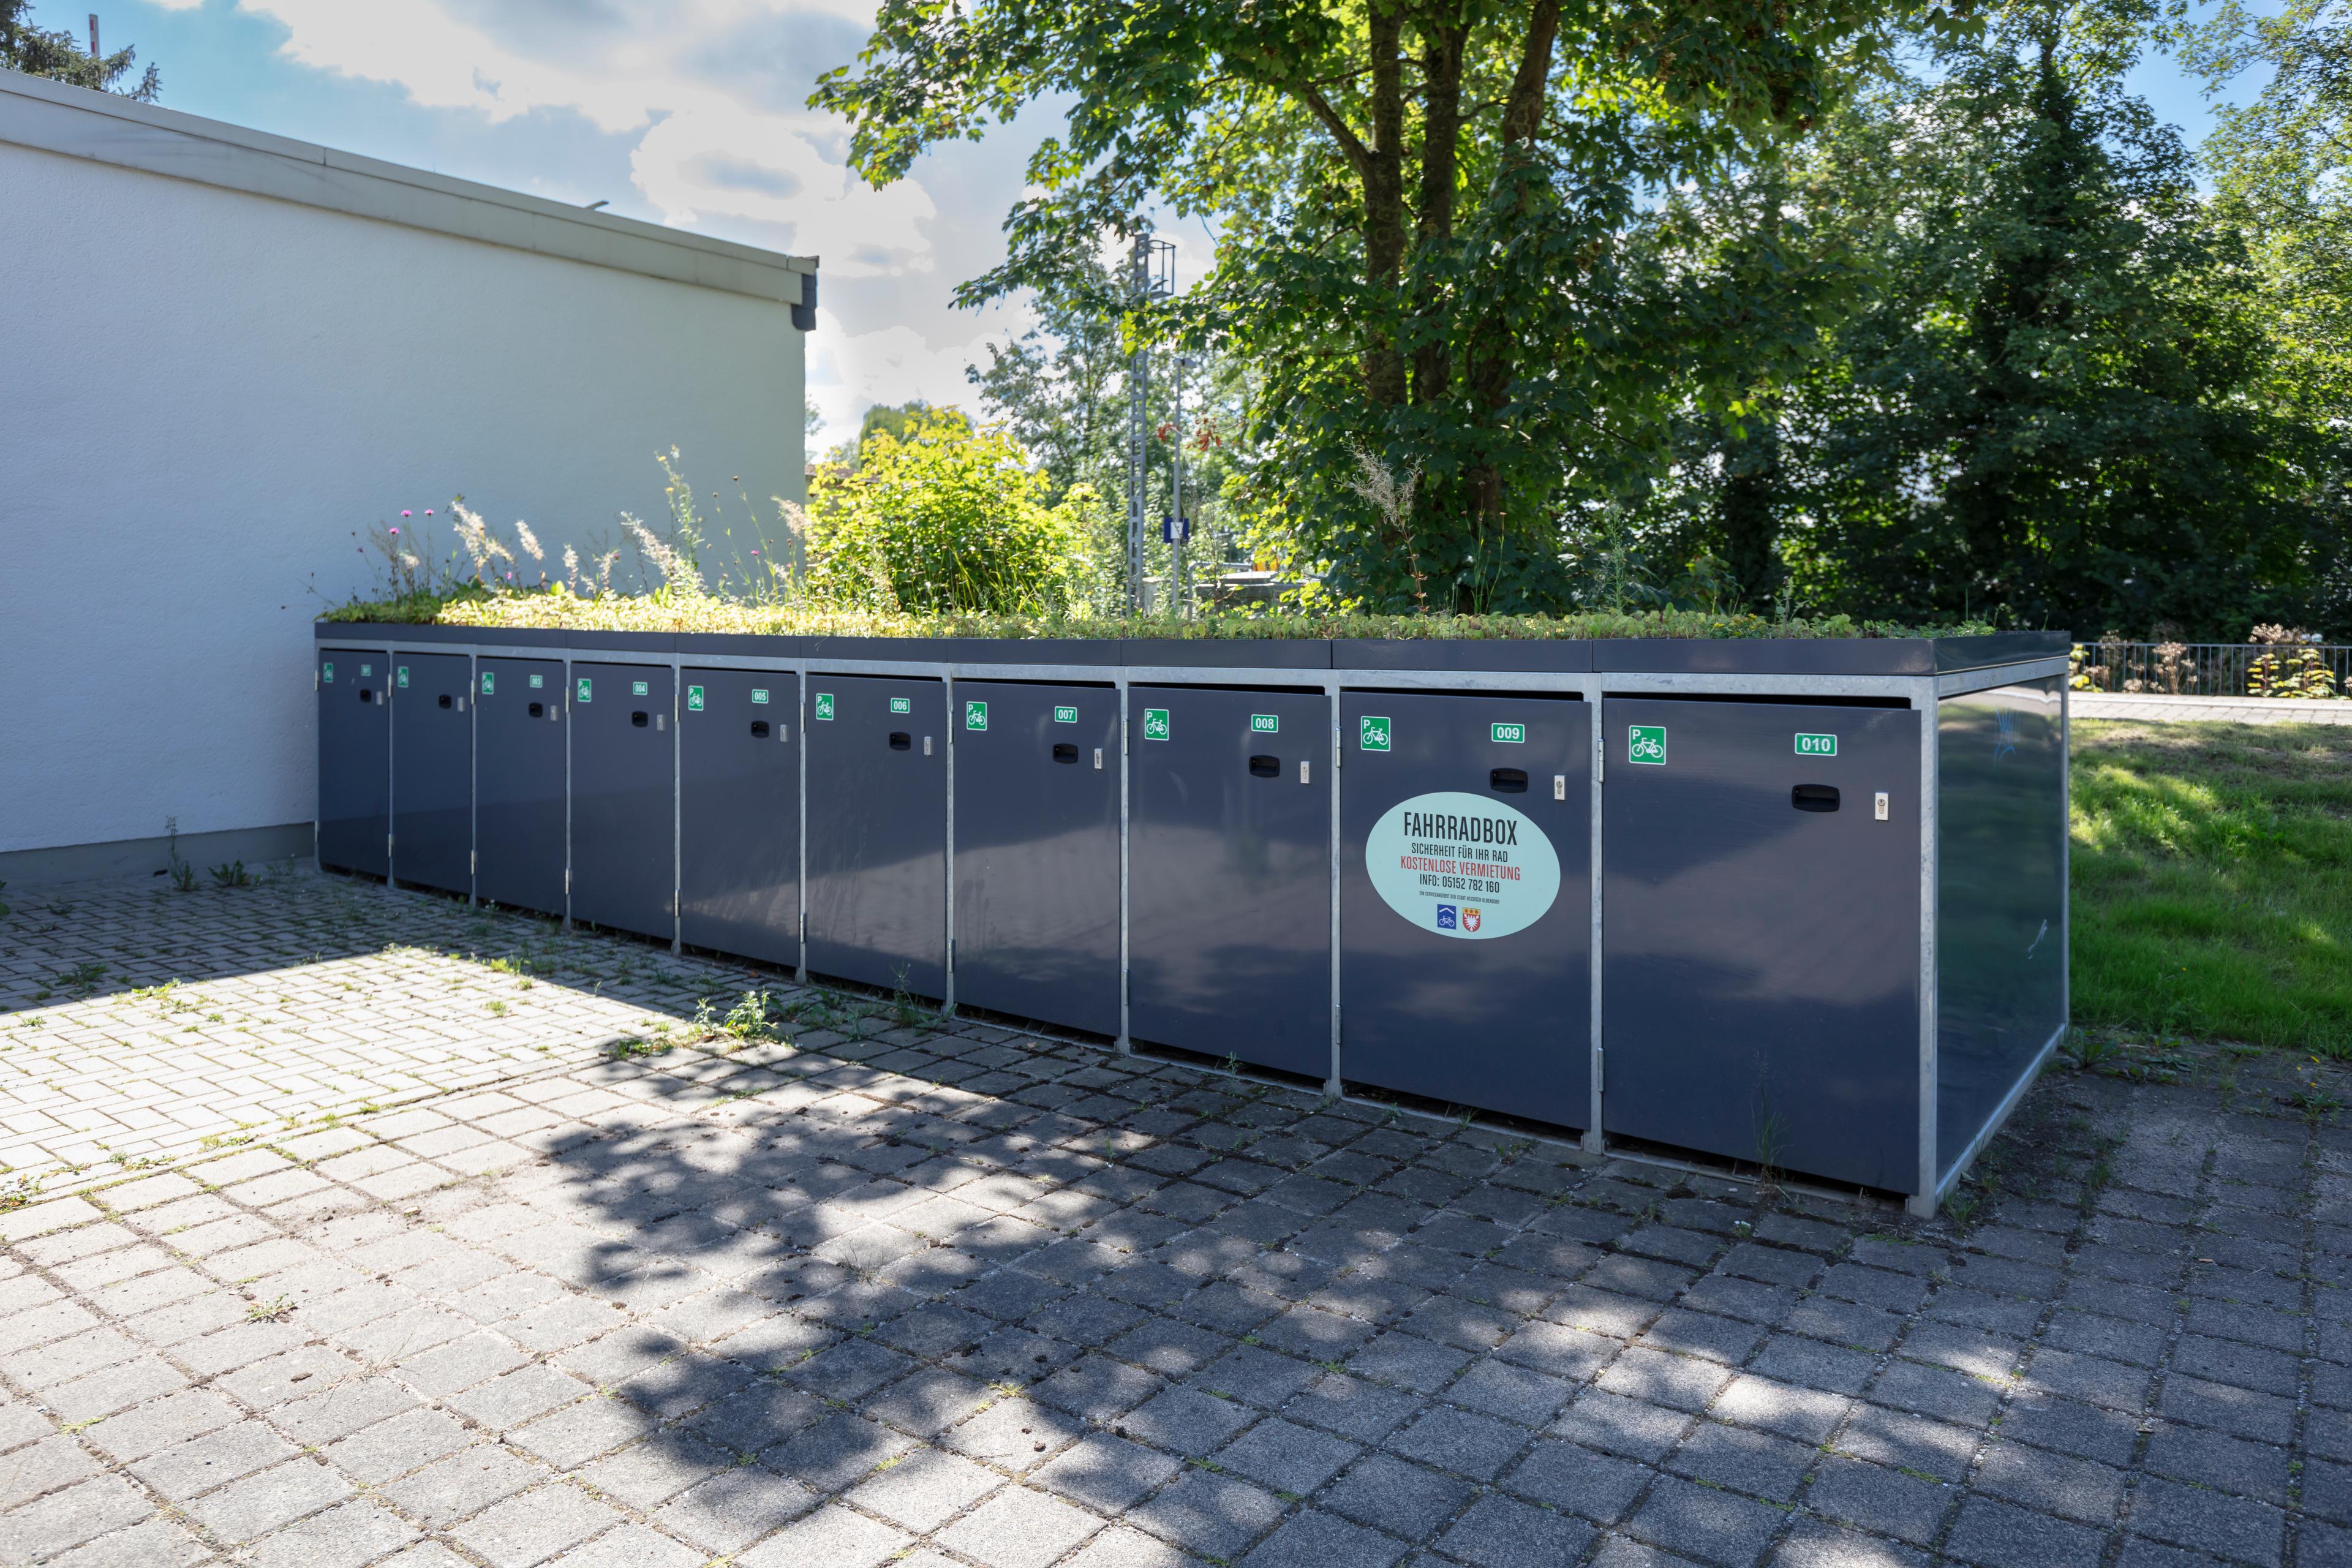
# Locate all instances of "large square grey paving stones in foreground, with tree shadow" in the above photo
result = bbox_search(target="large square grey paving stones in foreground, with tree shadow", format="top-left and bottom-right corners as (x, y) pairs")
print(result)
(0, 886), (2352, 1568)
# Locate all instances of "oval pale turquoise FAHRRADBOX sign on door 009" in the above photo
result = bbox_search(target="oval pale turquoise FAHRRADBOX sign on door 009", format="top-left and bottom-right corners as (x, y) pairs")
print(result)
(1364, 790), (1559, 940)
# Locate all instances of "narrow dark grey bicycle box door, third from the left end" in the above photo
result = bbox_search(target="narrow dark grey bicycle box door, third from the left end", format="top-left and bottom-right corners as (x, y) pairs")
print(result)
(473, 658), (567, 914)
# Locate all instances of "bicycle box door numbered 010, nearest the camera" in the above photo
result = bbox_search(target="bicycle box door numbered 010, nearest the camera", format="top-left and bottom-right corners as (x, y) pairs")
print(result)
(1602, 696), (1919, 1192)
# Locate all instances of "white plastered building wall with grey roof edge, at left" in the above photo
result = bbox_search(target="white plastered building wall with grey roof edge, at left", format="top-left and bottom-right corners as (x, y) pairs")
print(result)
(0, 73), (816, 881)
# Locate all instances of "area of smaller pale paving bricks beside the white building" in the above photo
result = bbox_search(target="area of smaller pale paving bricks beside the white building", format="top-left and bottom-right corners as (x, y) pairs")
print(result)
(0, 872), (790, 1189)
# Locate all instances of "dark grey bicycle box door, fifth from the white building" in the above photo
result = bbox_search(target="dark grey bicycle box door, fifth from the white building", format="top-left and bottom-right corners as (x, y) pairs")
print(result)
(677, 670), (802, 968)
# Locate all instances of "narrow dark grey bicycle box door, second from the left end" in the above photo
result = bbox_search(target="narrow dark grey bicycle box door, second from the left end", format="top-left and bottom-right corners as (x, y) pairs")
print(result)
(393, 654), (473, 893)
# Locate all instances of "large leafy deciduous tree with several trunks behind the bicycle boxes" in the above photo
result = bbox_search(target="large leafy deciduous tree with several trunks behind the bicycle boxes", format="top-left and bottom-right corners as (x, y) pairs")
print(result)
(814, 0), (1943, 609)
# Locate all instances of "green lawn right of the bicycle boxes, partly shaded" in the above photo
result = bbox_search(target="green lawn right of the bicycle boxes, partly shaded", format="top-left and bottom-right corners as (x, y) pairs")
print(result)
(2072, 719), (2352, 1058)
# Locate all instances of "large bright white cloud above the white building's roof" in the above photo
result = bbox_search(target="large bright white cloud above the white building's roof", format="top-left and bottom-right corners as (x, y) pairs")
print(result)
(227, 0), (936, 277)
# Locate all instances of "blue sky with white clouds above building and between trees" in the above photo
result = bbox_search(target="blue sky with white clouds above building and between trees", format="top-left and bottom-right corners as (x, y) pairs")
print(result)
(31, 0), (2270, 451)
